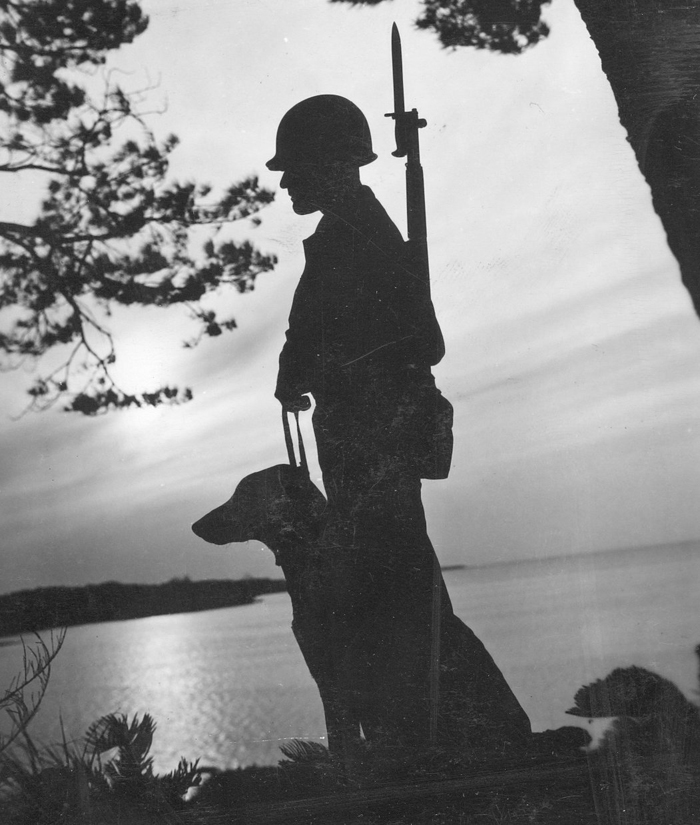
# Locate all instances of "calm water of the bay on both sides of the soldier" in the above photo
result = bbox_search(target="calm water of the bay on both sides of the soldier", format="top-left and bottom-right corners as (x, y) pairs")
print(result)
(0, 545), (700, 771)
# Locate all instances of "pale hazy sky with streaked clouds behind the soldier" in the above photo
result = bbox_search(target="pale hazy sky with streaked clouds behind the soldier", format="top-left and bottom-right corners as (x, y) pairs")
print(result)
(0, 0), (700, 592)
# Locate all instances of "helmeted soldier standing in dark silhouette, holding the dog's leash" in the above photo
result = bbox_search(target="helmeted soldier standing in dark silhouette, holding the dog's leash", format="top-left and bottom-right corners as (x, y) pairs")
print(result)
(267, 95), (529, 754)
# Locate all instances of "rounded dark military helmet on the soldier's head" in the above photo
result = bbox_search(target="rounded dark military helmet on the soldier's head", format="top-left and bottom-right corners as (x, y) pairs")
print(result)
(266, 95), (377, 172)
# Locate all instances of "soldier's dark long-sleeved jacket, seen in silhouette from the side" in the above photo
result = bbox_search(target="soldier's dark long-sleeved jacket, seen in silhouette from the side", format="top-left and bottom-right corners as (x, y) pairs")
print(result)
(276, 186), (444, 404)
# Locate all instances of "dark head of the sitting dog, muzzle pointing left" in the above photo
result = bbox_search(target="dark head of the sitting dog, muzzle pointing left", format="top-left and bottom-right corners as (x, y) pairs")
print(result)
(192, 464), (326, 561)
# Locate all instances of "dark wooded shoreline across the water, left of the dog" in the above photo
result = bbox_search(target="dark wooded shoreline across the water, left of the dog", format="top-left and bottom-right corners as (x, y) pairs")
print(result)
(0, 578), (287, 637)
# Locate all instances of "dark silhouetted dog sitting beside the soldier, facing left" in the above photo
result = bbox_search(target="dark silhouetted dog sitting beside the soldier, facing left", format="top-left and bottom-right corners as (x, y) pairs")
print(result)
(192, 464), (530, 758)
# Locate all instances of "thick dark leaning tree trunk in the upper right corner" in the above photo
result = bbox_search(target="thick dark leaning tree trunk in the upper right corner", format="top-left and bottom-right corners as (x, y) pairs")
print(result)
(576, 0), (700, 315)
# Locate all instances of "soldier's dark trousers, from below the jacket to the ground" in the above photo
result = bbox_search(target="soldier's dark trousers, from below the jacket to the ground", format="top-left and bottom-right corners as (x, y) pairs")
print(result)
(314, 400), (434, 746)
